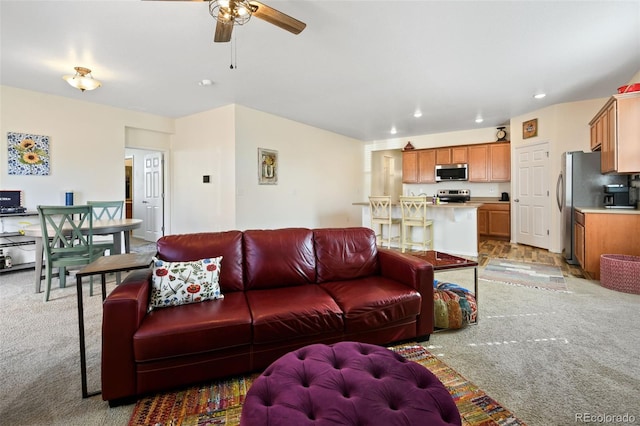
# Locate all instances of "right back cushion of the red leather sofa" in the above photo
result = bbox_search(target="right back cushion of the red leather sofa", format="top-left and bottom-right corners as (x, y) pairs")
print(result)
(313, 228), (378, 283)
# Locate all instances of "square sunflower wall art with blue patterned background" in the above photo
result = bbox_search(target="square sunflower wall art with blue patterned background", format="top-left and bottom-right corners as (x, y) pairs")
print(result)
(7, 132), (49, 176)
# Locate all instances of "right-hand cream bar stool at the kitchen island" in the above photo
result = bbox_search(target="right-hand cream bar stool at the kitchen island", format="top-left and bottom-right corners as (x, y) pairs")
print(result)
(400, 196), (433, 253)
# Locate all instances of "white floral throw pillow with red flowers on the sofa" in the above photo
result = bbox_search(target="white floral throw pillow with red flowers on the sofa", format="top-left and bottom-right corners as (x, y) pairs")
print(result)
(149, 256), (224, 312)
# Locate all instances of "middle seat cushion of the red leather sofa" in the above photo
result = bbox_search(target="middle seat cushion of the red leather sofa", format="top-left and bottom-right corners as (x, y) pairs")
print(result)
(245, 284), (344, 344)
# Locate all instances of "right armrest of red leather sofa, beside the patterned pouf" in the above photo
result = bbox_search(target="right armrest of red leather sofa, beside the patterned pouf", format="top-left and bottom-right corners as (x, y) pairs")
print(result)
(378, 248), (434, 337)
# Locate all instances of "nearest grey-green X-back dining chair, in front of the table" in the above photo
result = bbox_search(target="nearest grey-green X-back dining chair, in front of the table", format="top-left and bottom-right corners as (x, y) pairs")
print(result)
(38, 205), (113, 302)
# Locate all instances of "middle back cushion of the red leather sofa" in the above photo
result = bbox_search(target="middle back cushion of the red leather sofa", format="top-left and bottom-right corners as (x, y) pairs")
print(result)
(244, 228), (316, 290)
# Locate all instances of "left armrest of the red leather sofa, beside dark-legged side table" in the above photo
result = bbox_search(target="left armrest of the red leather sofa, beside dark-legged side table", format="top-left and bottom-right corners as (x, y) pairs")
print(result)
(102, 269), (151, 401)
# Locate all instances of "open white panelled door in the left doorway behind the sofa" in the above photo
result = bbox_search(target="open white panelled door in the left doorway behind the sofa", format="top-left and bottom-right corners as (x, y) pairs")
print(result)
(142, 152), (164, 241)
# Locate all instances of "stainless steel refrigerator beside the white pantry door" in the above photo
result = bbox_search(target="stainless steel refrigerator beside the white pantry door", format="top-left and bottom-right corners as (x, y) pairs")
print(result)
(556, 151), (628, 265)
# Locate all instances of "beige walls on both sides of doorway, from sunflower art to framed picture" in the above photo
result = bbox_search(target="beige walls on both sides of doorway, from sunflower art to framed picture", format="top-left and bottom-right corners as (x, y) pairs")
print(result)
(0, 86), (363, 240)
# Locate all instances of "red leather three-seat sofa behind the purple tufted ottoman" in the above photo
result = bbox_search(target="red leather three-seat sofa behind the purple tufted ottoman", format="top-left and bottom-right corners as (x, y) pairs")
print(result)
(102, 228), (434, 405)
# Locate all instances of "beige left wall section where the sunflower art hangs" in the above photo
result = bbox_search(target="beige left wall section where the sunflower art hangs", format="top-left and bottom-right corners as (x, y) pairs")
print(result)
(0, 86), (173, 210)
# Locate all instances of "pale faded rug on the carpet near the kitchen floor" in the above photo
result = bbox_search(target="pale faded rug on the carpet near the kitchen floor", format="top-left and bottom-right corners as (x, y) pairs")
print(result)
(478, 259), (568, 292)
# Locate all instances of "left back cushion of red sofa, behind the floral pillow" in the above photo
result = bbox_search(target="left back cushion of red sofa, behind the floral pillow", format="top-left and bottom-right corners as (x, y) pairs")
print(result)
(156, 231), (244, 294)
